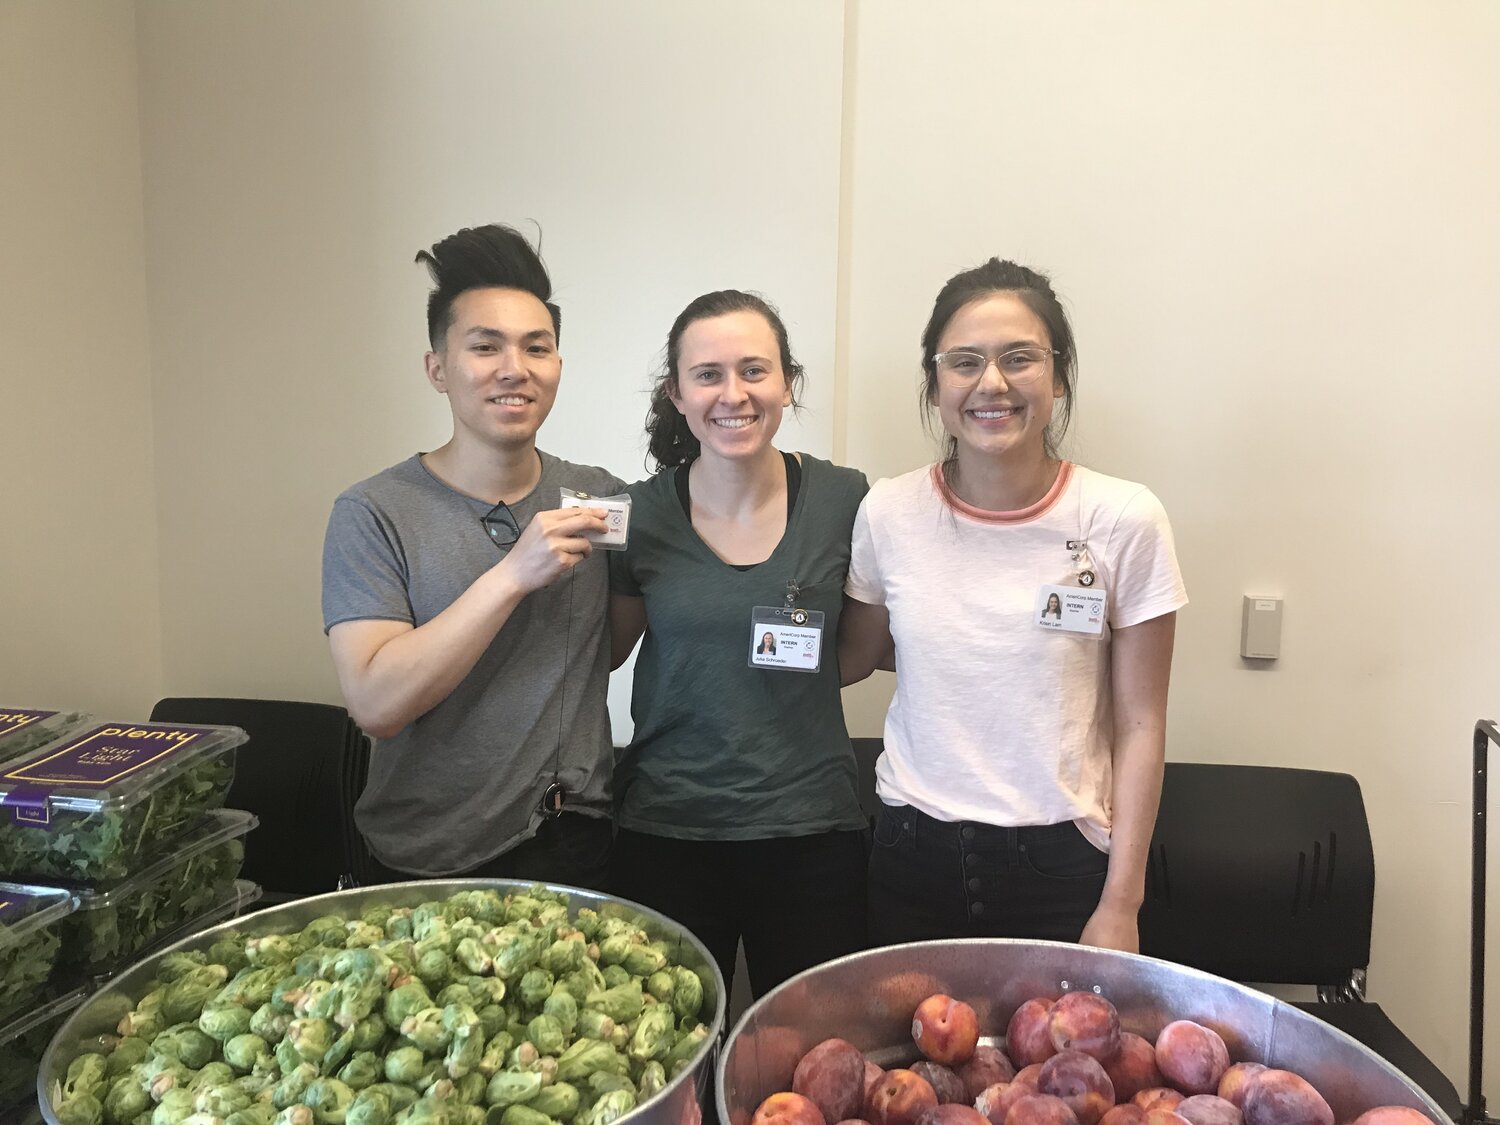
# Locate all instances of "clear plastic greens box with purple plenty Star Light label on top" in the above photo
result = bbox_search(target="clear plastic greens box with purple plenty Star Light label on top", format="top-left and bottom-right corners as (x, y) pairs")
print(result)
(0, 723), (248, 887)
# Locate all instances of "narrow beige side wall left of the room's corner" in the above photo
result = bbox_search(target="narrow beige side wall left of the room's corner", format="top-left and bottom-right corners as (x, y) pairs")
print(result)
(0, 0), (162, 716)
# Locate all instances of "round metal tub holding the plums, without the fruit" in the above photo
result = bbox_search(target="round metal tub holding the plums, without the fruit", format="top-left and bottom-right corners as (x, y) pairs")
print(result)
(717, 939), (1448, 1125)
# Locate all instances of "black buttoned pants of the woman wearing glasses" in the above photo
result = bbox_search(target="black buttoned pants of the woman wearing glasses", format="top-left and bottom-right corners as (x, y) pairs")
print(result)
(870, 806), (1109, 945)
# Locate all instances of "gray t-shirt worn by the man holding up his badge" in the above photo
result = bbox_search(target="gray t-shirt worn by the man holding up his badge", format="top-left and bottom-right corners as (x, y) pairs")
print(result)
(323, 450), (624, 876)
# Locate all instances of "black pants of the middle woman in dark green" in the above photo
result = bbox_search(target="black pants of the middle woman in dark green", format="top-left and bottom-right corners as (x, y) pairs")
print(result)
(611, 828), (866, 1002)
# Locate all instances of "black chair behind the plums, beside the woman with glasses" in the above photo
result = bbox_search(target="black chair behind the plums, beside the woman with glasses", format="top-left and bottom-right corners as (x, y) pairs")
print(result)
(1140, 762), (1463, 1121)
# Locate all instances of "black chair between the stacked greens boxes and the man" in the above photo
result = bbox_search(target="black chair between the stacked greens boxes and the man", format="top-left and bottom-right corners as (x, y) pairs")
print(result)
(152, 699), (369, 905)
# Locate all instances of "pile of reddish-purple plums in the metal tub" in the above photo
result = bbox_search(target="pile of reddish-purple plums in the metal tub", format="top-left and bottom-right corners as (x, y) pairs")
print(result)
(752, 992), (1433, 1125)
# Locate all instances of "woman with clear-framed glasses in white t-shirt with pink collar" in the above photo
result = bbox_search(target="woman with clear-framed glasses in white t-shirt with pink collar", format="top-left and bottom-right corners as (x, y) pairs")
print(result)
(839, 258), (1187, 950)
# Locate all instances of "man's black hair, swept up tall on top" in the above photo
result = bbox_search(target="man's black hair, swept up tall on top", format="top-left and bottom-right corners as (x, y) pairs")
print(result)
(417, 224), (563, 351)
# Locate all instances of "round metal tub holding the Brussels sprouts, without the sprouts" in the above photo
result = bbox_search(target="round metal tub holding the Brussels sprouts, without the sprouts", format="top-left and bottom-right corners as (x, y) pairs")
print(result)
(36, 879), (725, 1125)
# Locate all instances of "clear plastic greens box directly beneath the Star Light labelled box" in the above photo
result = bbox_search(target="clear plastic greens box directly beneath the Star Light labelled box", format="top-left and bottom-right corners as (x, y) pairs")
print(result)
(57, 809), (260, 981)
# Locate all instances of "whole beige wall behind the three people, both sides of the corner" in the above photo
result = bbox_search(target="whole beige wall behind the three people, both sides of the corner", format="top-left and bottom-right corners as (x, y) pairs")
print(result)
(0, 0), (1500, 1097)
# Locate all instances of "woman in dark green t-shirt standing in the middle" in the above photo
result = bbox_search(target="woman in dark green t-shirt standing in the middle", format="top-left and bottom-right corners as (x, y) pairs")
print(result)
(611, 290), (869, 995)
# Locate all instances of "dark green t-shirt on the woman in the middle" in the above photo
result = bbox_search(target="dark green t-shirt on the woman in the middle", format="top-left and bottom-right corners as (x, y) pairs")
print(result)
(609, 453), (870, 840)
